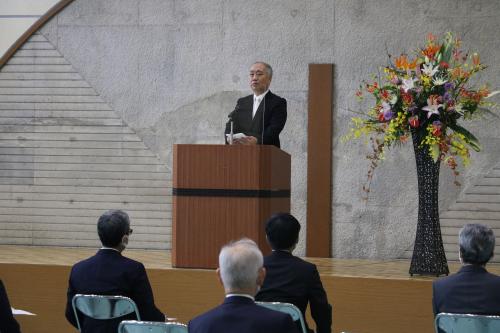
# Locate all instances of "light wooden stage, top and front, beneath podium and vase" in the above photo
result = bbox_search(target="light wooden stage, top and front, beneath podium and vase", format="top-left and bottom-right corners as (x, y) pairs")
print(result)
(0, 245), (500, 333)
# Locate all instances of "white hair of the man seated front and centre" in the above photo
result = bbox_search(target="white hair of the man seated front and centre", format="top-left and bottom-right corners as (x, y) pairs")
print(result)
(219, 238), (264, 290)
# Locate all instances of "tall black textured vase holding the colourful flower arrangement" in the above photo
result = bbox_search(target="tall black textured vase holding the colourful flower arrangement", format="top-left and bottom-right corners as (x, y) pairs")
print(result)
(410, 131), (449, 276)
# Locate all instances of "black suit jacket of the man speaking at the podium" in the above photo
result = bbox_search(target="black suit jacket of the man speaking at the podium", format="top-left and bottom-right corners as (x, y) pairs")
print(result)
(225, 91), (286, 148)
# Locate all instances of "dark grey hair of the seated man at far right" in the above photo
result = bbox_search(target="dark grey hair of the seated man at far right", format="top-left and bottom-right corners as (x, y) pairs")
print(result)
(458, 224), (495, 265)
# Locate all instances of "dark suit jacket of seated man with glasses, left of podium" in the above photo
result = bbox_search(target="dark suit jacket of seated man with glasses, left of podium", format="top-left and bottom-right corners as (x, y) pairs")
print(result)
(66, 249), (165, 333)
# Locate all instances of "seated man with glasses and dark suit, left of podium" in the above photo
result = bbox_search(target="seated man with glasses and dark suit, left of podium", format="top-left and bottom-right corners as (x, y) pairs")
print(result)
(66, 210), (165, 333)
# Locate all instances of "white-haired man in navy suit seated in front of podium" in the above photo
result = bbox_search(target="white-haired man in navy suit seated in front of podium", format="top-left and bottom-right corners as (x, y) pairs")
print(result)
(188, 239), (298, 333)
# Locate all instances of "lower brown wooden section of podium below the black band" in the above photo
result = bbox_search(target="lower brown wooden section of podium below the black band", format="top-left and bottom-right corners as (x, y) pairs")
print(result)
(172, 197), (290, 268)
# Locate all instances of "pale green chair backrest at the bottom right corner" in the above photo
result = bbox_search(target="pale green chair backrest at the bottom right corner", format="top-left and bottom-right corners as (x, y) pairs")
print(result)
(434, 313), (500, 333)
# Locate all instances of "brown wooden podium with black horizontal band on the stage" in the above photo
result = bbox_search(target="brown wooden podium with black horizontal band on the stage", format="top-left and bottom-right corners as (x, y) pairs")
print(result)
(172, 145), (291, 268)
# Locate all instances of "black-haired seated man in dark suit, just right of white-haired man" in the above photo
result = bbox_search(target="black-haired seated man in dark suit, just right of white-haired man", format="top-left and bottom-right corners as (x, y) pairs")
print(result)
(255, 213), (332, 333)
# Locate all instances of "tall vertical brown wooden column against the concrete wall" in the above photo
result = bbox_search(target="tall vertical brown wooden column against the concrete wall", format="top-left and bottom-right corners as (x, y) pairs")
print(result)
(306, 64), (333, 257)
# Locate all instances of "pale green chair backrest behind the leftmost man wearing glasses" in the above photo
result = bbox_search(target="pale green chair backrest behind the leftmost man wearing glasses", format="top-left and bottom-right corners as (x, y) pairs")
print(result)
(72, 294), (141, 331)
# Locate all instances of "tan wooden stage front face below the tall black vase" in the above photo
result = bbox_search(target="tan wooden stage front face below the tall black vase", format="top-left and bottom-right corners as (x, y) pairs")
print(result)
(328, 276), (434, 333)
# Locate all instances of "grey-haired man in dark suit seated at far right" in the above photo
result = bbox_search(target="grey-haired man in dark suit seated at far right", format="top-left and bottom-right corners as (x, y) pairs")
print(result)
(432, 224), (500, 316)
